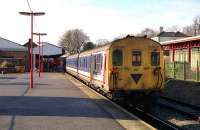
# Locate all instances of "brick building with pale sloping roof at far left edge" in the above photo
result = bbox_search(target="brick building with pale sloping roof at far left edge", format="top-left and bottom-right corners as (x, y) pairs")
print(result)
(0, 37), (29, 73)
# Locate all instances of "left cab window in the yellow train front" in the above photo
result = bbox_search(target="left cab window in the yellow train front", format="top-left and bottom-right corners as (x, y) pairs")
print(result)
(112, 49), (123, 66)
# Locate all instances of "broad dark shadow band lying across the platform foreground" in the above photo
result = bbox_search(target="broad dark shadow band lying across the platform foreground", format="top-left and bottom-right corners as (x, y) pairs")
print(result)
(0, 96), (130, 119)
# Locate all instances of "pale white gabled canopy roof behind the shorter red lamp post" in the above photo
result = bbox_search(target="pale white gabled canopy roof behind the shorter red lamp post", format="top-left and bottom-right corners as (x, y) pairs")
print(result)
(33, 42), (64, 57)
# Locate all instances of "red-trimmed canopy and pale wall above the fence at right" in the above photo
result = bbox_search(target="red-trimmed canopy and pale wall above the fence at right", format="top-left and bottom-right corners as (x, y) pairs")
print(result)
(161, 36), (200, 65)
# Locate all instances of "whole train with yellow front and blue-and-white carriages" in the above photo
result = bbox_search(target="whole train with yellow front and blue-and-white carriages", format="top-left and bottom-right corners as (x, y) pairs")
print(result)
(66, 35), (164, 103)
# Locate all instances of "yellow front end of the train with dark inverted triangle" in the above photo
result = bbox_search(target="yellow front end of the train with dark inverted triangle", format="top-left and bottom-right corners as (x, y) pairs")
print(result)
(109, 37), (164, 100)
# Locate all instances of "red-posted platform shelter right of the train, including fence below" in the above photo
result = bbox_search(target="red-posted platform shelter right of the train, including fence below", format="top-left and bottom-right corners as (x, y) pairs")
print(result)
(161, 36), (200, 81)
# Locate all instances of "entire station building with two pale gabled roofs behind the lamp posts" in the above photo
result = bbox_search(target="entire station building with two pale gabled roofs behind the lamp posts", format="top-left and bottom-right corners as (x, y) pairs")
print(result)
(0, 37), (65, 73)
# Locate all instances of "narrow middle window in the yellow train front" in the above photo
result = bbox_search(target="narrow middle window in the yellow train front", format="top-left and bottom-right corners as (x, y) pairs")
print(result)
(132, 51), (141, 66)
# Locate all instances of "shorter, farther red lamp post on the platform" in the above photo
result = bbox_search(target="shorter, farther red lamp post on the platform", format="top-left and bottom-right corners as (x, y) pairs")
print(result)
(33, 33), (47, 78)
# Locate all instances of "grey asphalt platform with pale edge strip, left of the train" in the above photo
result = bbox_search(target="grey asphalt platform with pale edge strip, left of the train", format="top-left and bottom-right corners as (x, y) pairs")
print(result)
(0, 73), (154, 130)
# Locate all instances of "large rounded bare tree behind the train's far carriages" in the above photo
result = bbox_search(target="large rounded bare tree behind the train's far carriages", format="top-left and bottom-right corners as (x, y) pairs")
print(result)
(59, 29), (89, 54)
